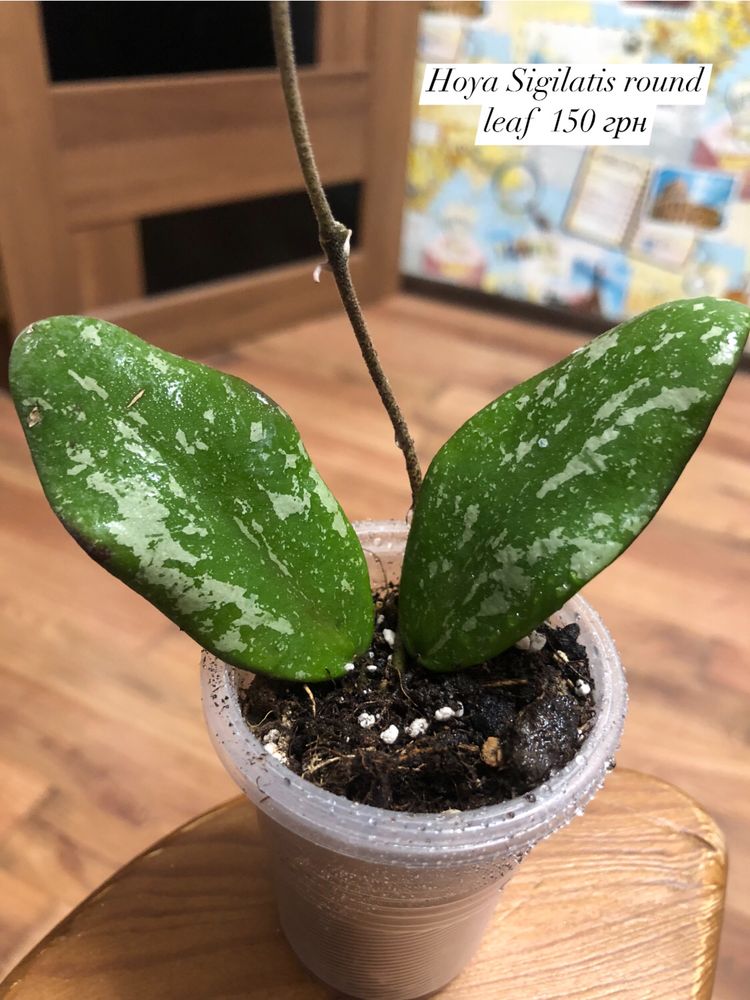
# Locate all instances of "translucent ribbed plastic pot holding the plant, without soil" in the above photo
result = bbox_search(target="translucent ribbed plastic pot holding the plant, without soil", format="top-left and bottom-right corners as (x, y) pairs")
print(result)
(203, 521), (627, 1000)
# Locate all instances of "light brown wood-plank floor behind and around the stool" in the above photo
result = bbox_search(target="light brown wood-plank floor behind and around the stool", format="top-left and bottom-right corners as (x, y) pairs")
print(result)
(0, 297), (750, 1000)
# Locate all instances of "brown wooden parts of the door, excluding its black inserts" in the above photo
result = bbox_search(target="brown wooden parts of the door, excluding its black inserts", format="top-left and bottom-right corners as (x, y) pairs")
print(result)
(0, 0), (419, 360)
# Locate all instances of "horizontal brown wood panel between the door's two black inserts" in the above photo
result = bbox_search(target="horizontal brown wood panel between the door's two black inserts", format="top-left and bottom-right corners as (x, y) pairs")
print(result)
(53, 68), (368, 229)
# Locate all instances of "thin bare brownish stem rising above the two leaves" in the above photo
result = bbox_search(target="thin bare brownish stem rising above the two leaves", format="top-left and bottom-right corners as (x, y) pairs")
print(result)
(271, 0), (422, 506)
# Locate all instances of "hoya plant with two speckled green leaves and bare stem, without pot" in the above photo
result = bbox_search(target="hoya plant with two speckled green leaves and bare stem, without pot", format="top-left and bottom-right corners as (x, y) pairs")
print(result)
(5, 3), (750, 682)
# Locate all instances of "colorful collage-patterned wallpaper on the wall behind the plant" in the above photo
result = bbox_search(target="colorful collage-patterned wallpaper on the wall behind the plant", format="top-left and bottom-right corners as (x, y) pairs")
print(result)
(402, 0), (750, 320)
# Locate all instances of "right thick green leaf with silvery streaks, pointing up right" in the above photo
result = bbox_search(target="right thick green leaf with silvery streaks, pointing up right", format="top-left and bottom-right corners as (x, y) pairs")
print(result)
(400, 298), (750, 670)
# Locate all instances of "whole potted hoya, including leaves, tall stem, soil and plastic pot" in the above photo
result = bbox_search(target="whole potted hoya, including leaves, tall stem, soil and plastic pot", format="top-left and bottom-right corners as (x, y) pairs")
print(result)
(10, 3), (750, 1000)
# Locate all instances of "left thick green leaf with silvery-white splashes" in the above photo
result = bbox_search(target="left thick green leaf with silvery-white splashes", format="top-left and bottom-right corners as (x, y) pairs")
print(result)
(11, 316), (373, 680)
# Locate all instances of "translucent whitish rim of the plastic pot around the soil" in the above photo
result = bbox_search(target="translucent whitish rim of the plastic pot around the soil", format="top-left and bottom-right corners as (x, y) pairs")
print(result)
(201, 521), (627, 863)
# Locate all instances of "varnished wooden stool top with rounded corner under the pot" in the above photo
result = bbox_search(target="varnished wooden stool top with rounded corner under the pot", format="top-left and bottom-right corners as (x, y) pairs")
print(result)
(0, 771), (726, 1000)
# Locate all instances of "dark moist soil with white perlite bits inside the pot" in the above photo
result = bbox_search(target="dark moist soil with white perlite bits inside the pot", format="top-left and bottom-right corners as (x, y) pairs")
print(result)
(243, 588), (594, 812)
